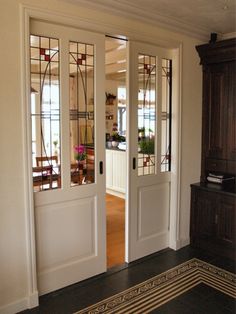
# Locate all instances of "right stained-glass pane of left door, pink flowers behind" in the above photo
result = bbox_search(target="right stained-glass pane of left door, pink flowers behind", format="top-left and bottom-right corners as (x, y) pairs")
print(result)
(69, 42), (95, 186)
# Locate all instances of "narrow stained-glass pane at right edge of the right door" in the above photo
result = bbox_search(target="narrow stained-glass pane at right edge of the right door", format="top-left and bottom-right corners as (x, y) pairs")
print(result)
(161, 59), (172, 172)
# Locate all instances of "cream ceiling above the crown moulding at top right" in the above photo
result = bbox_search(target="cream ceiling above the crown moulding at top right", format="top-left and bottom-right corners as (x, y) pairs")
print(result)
(64, 0), (236, 40)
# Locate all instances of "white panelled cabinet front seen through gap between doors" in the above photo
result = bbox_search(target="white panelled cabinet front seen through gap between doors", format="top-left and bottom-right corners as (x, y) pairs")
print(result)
(106, 149), (127, 197)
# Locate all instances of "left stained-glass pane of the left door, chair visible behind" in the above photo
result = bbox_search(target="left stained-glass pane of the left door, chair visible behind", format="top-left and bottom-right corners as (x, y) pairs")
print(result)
(30, 35), (61, 191)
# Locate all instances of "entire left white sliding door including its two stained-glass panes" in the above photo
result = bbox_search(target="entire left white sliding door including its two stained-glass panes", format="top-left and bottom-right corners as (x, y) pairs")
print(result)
(30, 21), (106, 294)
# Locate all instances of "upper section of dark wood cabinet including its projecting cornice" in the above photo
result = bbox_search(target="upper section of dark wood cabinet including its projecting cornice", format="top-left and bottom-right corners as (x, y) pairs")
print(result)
(196, 39), (236, 182)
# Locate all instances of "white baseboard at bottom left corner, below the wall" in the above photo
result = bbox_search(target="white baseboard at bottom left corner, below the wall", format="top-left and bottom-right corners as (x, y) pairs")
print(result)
(0, 292), (38, 314)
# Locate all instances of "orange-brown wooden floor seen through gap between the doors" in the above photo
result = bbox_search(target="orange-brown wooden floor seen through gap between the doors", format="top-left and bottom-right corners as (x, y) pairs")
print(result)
(106, 194), (125, 268)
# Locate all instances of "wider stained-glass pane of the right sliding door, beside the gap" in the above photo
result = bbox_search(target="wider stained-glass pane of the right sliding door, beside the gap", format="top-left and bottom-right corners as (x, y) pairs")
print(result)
(138, 54), (156, 176)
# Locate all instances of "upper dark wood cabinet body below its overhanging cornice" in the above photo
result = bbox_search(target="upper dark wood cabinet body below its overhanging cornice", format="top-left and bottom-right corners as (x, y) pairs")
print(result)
(202, 61), (236, 174)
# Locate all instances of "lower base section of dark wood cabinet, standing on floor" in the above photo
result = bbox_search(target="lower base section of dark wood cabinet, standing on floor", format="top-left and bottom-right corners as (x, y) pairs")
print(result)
(190, 184), (236, 259)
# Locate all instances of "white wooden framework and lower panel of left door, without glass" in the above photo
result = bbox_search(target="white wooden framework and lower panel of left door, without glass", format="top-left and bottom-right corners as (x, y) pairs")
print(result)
(30, 20), (106, 295)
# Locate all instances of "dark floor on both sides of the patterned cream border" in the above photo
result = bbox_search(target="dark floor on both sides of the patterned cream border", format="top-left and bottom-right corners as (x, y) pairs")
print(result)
(21, 246), (236, 314)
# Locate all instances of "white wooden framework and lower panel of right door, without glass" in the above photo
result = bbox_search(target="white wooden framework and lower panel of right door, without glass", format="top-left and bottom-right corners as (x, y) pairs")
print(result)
(126, 41), (171, 262)
